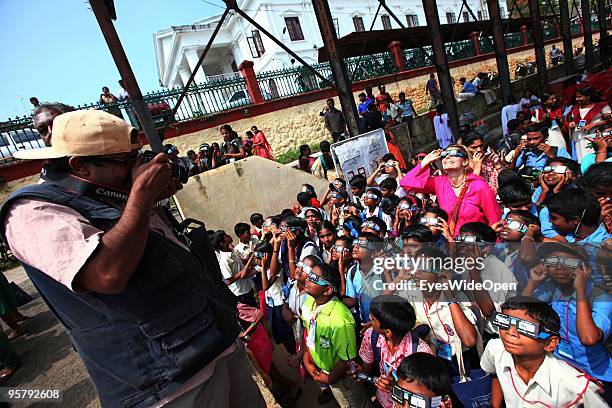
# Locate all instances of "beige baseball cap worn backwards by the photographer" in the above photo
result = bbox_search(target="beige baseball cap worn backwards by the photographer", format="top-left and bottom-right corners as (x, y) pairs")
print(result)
(13, 109), (142, 160)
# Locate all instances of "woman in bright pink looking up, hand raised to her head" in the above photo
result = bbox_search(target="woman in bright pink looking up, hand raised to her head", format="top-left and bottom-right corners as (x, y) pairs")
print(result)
(400, 145), (502, 237)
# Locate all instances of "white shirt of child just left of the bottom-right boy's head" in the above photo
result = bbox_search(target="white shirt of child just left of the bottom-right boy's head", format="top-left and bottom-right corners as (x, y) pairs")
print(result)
(411, 292), (478, 356)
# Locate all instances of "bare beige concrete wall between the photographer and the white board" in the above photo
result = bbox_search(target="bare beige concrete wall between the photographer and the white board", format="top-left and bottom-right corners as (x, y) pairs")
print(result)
(176, 157), (329, 235)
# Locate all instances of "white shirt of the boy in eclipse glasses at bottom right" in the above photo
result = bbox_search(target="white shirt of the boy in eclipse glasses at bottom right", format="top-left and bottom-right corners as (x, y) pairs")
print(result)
(480, 339), (608, 408)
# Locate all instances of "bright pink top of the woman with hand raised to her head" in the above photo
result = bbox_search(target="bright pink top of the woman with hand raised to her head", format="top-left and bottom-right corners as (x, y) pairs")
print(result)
(400, 163), (502, 237)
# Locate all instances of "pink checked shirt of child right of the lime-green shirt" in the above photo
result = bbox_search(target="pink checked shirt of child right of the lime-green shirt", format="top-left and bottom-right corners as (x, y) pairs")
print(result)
(359, 328), (433, 408)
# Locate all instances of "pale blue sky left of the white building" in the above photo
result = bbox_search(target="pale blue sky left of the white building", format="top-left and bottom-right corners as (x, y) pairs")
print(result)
(0, 0), (223, 118)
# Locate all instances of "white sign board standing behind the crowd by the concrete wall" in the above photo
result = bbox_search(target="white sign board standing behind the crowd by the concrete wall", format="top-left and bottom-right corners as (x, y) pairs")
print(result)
(331, 129), (389, 182)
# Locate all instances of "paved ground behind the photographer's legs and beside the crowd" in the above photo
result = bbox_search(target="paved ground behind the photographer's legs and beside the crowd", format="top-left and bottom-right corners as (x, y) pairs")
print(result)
(2, 268), (337, 408)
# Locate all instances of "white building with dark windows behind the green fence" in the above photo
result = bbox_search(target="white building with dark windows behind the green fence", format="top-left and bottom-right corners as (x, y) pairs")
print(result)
(153, 0), (506, 88)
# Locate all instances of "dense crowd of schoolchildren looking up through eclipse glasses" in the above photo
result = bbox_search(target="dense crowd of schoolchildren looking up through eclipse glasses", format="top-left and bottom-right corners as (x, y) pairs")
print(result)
(210, 75), (612, 407)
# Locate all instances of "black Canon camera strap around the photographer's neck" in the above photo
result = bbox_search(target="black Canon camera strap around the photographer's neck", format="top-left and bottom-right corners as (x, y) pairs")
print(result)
(40, 167), (168, 207)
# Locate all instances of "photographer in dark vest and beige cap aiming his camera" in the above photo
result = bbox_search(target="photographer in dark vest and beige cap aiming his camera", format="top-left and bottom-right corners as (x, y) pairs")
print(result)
(0, 110), (264, 407)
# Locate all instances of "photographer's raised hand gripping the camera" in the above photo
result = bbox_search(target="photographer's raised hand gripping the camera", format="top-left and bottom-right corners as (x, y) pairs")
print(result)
(132, 153), (183, 204)
